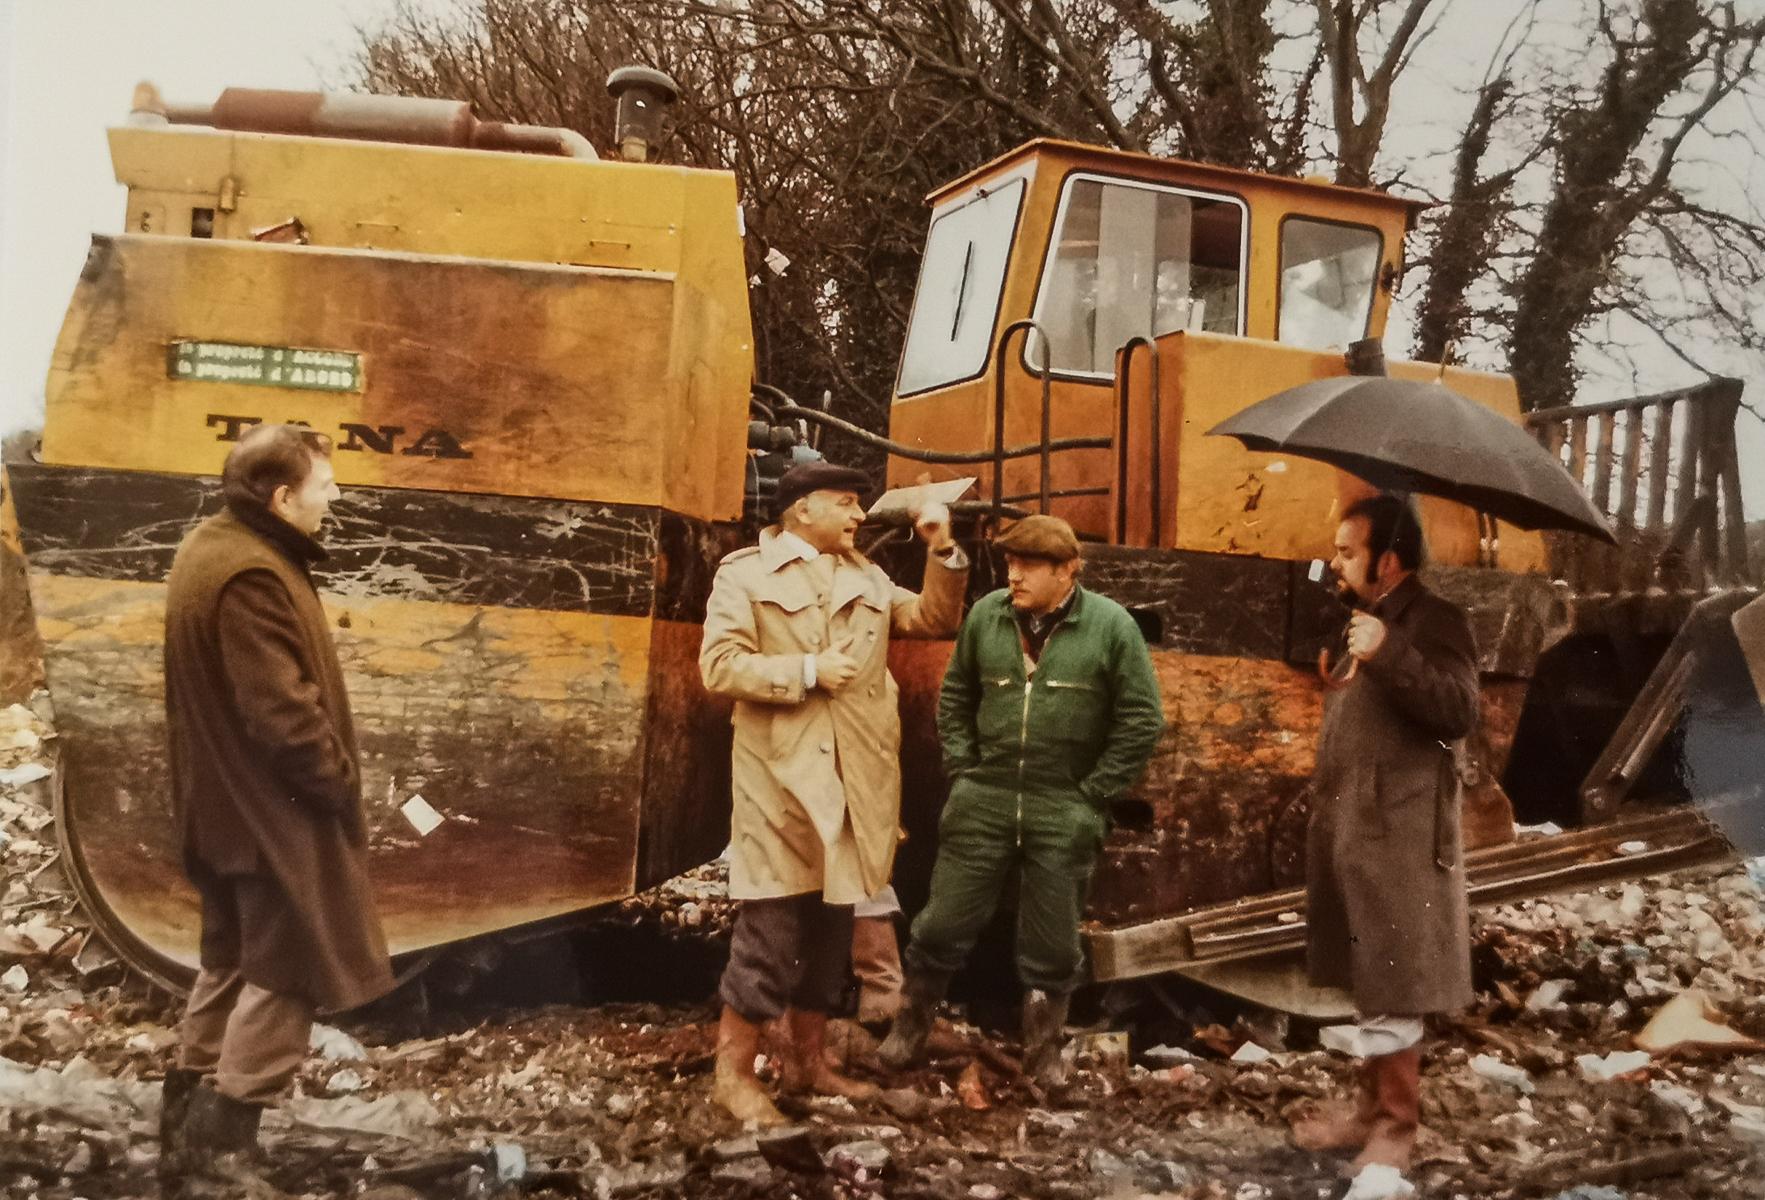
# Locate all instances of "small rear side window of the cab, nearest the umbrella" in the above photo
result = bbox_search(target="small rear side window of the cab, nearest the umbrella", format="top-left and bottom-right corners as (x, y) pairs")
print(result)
(1276, 217), (1384, 349)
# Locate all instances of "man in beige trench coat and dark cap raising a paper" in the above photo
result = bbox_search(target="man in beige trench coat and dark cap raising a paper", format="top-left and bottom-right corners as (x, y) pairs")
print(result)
(699, 462), (967, 1124)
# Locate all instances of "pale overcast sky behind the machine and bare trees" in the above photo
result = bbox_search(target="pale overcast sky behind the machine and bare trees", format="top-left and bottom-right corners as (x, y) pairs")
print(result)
(0, 0), (1765, 515)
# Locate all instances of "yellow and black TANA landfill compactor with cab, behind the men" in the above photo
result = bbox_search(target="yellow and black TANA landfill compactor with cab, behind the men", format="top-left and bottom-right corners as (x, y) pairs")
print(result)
(7, 82), (1758, 1006)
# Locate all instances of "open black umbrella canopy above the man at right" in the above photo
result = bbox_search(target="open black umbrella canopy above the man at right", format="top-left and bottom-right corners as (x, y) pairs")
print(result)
(1207, 376), (1615, 542)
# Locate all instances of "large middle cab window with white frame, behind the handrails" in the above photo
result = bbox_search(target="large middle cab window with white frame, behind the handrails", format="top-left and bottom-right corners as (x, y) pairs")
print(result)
(1024, 175), (1246, 378)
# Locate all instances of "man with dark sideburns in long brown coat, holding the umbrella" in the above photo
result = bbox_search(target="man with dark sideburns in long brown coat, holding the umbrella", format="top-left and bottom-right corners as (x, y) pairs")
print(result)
(1294, 496), (1477, 1174)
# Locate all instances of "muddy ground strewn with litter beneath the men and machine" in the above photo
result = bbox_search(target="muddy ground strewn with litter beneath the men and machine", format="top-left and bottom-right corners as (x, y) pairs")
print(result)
(0, 698), (1765, 1200)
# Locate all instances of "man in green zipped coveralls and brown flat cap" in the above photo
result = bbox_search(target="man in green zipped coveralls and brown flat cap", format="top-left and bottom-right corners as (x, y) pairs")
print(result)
(881, 515), (1165, 1085)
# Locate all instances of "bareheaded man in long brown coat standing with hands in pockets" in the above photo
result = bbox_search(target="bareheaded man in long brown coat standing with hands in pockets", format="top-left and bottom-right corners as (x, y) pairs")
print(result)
(161, 425), (392, 1175)
